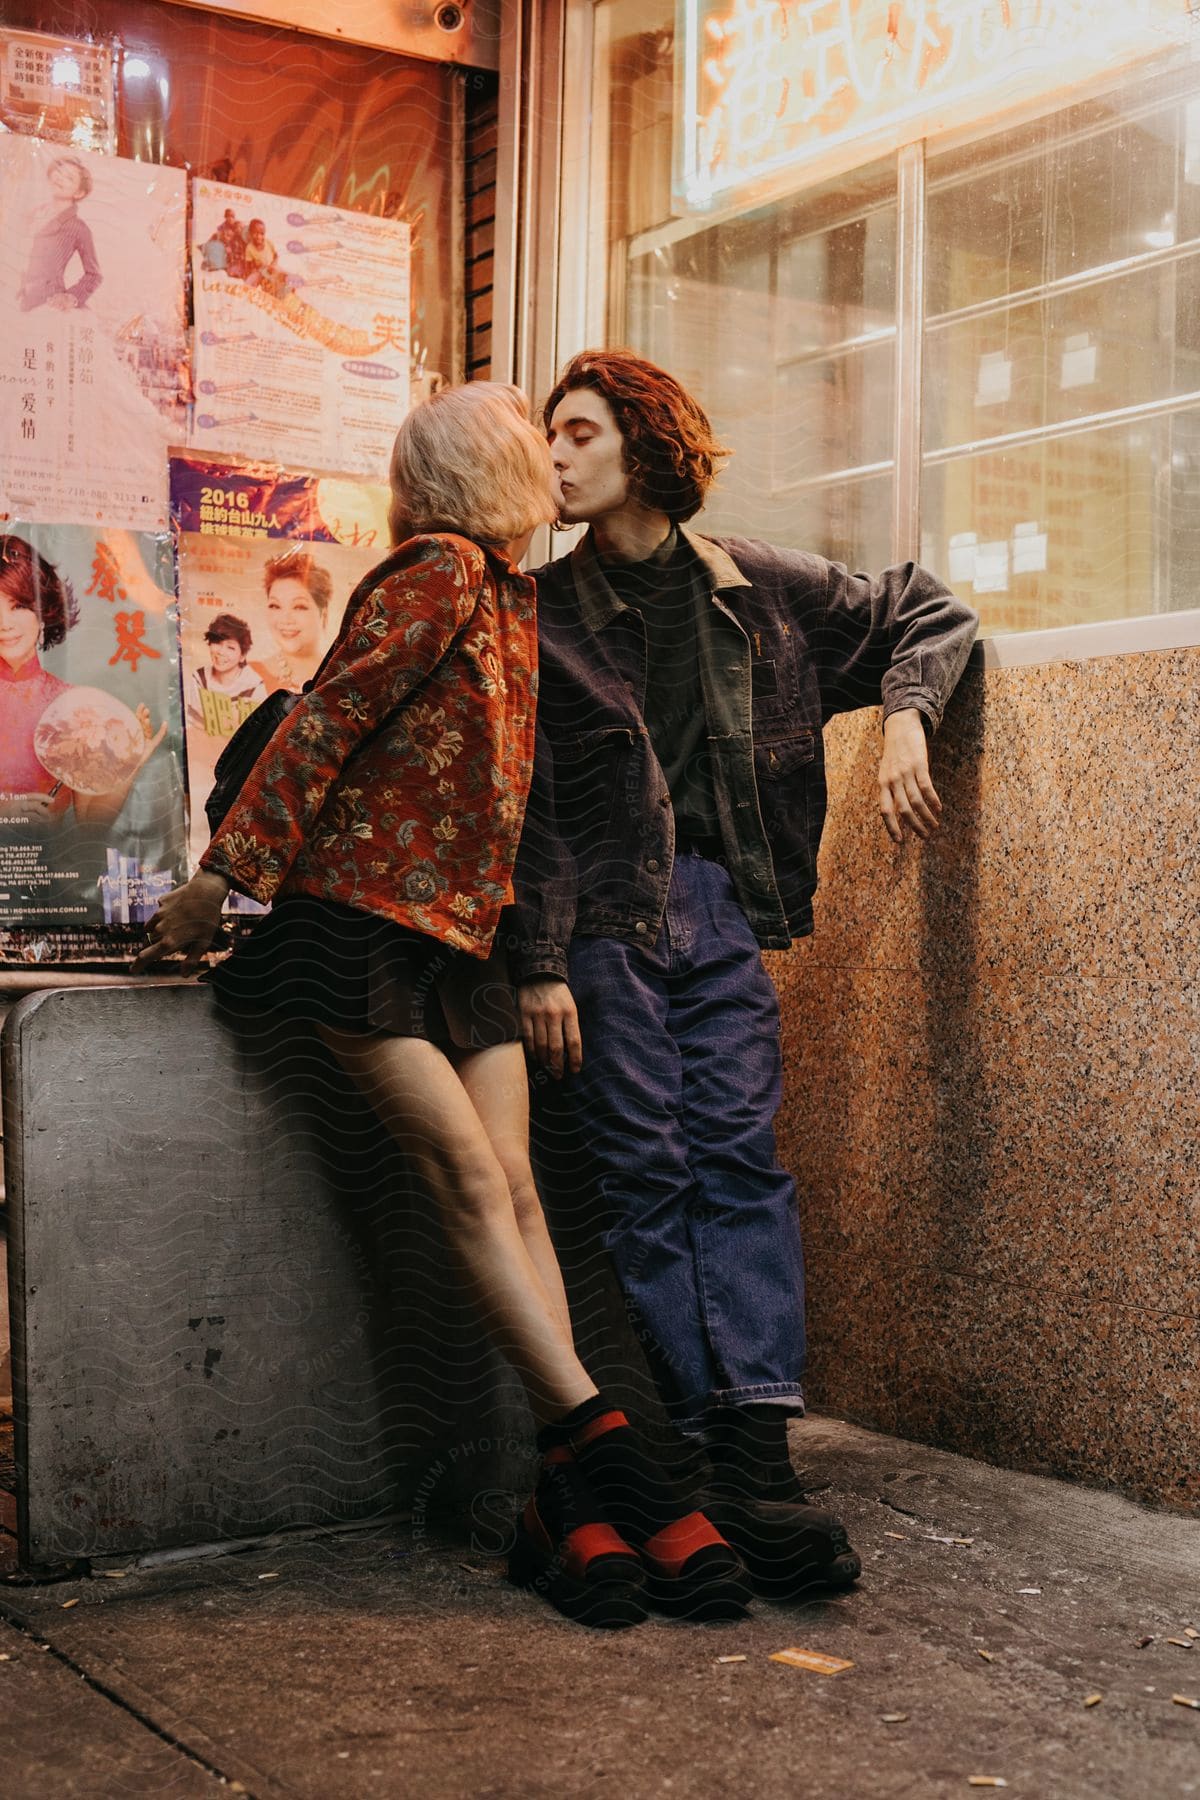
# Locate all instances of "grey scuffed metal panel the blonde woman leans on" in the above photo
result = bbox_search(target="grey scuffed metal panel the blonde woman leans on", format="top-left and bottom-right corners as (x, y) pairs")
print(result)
(4, 983), (531, 1566)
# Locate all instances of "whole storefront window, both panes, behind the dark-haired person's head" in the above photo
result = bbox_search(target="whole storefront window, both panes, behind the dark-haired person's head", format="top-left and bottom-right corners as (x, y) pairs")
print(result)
(586, 0), (1200, 632)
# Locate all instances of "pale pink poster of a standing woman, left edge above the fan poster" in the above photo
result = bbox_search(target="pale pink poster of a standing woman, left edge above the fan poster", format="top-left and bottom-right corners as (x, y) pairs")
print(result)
(0, 137), (187, 531)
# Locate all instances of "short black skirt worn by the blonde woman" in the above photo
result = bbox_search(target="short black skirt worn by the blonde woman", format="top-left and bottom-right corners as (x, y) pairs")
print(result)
(205, 895), (520, 1049)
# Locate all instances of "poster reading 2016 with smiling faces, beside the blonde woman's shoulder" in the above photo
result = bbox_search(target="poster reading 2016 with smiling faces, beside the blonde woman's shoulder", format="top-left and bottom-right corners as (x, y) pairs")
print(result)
(171, 452), (389, 871)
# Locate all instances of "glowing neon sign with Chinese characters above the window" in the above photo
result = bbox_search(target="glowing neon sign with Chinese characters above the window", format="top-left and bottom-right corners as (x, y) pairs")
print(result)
(675, 0), (1195, 212)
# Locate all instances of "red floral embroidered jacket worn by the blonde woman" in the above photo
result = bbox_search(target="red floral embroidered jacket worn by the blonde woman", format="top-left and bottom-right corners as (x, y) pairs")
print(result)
(201, 533), (538, 956)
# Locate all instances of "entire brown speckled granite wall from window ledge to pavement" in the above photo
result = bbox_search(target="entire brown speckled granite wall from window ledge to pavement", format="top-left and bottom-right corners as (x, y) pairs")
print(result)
(768, 650), (1200, 1510)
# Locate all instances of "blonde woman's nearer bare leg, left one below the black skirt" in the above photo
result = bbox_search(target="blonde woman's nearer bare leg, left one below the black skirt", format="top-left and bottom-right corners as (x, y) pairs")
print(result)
(318, 1026), (596, 1420)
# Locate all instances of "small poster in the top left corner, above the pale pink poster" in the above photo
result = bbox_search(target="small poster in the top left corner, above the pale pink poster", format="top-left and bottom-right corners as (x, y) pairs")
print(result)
(0, 25), (117, 157)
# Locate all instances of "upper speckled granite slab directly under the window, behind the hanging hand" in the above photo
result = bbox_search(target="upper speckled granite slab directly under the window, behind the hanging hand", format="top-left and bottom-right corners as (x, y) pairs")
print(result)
(817, 652), (1200, 976)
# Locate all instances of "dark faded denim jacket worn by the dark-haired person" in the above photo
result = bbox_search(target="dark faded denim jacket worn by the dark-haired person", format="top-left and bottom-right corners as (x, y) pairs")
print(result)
(513, 533), (979, 981)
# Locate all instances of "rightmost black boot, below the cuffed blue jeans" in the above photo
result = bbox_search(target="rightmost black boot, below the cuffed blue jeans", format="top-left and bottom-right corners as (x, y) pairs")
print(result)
(703, 1404), (862, 1600)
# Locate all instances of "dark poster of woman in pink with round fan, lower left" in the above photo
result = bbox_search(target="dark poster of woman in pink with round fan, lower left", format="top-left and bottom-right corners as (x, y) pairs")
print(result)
(0, 522), (187, 932)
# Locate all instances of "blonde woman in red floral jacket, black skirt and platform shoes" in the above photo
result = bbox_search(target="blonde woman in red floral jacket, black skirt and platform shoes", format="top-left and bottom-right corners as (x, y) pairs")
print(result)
(135, 382), (748, 1625)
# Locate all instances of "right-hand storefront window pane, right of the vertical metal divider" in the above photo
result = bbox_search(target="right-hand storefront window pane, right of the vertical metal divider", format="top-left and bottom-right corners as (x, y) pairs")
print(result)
(923, 75), (1200, 630)
